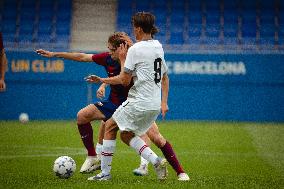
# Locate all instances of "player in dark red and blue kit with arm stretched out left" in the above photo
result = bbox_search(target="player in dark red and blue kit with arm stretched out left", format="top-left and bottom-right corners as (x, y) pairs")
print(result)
(36, 32), (131, 173)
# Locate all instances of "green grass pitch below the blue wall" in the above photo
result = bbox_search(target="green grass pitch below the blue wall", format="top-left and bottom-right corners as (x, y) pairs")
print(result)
(0, 121), (284, 189)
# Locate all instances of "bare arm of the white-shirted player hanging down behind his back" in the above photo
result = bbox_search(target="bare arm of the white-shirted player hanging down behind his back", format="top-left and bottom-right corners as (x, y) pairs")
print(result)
(161, 73), (169, 118)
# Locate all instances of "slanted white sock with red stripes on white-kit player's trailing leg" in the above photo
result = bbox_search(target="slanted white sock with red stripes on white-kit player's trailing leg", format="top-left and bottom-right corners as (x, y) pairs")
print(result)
(129, 136), (158, 165)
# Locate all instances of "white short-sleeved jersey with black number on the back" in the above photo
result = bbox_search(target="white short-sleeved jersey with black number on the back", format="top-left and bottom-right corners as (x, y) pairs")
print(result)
(124, 40), (168, 110)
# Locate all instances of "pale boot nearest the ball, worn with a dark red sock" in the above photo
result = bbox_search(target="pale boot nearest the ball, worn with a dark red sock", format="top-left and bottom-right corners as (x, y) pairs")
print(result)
(80, 156), (101, 173)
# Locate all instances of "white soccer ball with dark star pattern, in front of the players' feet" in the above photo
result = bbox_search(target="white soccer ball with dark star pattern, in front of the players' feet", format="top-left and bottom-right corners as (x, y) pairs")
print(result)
(53, 156), (76, 179)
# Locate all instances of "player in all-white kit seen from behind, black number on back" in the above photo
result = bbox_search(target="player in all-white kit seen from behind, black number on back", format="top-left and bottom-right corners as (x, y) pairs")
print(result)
(88, 12), (179, 180)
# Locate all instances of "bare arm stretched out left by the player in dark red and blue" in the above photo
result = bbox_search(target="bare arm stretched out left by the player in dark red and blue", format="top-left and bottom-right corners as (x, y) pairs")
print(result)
(35, 49), (93, 62)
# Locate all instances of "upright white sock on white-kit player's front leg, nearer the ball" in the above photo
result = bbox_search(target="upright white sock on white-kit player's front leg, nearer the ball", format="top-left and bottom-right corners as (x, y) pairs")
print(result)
(101, 140), (116, 175)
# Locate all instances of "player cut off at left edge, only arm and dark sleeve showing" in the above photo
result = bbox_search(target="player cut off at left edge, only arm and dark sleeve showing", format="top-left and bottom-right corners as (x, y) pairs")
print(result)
(0, 32), (7, 92)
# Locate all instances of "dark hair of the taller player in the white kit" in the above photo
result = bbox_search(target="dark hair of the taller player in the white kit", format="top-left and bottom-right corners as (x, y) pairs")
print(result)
(131, 12), (159, 36)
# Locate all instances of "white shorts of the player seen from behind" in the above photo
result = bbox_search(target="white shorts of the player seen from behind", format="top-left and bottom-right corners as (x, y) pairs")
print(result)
(112, 100), (160, 136)
